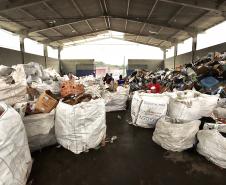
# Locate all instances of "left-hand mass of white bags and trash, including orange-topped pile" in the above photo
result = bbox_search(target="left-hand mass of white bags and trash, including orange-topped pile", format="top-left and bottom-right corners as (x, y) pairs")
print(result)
(0, 62), (129, 184)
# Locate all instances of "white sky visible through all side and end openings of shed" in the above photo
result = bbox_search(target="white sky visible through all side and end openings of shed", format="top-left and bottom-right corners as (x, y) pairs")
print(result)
(0, 21), (226, 65)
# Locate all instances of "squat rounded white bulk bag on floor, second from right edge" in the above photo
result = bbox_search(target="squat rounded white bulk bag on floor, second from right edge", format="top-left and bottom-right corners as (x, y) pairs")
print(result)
(152, 118), (201, 152)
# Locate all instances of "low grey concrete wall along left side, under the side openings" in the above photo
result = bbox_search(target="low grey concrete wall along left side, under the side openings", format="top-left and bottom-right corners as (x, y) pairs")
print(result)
(0, 47), (59, 72)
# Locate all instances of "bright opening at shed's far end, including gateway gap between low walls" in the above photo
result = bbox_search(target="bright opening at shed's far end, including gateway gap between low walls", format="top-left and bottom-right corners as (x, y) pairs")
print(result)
(61, 32), (163, 78)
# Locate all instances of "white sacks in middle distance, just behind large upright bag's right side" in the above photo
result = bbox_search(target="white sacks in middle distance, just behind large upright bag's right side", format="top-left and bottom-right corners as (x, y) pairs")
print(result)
(102, 86), (129, 112)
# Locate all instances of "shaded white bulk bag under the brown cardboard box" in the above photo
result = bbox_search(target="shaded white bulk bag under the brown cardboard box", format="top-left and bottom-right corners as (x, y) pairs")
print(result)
(23, 110), (57, 151)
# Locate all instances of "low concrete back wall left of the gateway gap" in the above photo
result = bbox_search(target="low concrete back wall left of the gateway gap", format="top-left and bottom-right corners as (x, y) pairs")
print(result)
(62, 59), (94, 75)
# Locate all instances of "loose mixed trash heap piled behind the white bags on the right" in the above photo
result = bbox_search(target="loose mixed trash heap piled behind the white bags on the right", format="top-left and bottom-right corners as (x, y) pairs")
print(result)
(129, 50), (226, 97)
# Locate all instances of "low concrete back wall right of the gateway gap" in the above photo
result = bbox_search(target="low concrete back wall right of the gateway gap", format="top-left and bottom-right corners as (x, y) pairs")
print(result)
(128, 59), (164, 71)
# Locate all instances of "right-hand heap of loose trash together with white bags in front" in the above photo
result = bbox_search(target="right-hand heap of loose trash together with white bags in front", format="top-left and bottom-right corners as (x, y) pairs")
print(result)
(129, 53), (226, 168)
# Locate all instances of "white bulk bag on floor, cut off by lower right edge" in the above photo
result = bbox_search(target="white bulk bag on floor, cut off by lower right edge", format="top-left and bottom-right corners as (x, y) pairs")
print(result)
(197, 126), (226, 168)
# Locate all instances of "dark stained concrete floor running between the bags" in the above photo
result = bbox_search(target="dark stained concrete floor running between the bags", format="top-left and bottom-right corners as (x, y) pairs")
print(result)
(30, 107), (226, 185)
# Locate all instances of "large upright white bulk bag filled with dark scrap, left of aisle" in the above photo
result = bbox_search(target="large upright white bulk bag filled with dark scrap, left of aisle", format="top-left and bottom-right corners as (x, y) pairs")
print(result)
(55, 99), (106, 154)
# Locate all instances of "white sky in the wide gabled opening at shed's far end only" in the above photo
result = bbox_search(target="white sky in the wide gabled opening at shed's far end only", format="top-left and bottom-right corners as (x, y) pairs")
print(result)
(61, 38), (163, 65)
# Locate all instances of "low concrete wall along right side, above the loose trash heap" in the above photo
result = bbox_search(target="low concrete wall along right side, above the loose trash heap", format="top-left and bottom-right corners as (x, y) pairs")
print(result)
(164, 43), (226, 68)
